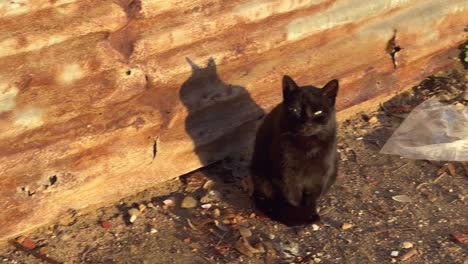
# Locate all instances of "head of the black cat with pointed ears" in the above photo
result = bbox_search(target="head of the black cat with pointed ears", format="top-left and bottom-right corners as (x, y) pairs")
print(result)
(283, 75), (338, 136)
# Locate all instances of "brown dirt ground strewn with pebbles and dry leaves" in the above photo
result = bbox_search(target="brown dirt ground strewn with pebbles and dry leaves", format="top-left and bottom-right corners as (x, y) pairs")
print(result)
(0, 67), (468, 264)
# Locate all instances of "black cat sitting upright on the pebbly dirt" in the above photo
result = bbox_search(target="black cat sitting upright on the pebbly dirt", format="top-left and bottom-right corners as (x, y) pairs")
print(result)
(251, 75), (338, 226)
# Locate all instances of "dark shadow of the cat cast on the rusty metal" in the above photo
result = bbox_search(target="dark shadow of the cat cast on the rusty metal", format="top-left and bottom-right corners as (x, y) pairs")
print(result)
(179, 58), (265, 208)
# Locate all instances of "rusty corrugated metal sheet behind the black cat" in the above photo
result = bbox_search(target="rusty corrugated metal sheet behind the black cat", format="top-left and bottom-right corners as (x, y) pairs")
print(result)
(0, 0), (468, 240)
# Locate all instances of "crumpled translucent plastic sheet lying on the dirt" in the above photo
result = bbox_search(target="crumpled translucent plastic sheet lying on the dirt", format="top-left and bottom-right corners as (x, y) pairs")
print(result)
(380, 97), (468, 161)
